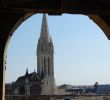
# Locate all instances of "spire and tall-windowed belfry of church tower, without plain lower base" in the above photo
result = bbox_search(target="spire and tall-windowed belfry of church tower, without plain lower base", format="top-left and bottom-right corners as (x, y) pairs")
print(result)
(36, 14), (54, 77)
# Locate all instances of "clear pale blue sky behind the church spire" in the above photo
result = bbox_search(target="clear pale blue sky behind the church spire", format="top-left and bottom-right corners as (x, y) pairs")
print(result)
(6, 14), (110, 85)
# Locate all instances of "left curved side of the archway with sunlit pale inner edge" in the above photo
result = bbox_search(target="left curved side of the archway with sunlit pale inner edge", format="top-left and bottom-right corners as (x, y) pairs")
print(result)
(0, 13), (33, 100)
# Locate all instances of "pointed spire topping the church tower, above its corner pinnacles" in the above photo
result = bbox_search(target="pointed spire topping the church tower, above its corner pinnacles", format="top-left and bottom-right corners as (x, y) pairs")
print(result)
(40, 14), (51, 42)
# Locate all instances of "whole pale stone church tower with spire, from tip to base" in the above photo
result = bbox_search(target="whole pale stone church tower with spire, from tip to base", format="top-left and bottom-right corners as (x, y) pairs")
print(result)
(37, 14), (55, 95)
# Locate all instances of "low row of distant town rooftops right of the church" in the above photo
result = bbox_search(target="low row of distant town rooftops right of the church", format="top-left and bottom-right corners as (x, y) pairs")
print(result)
(57, 82), (110, 95)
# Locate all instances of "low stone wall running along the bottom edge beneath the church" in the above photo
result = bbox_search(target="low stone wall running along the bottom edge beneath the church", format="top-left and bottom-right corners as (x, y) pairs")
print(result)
(6, 96), (110, 100)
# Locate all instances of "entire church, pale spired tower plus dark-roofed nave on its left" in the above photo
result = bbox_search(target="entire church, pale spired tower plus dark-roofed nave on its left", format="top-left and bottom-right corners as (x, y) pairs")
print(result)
(5, 14), (56, 95)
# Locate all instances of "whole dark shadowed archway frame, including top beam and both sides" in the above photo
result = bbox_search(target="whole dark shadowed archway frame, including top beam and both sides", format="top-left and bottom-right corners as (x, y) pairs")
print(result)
(0, 0), (110, 100)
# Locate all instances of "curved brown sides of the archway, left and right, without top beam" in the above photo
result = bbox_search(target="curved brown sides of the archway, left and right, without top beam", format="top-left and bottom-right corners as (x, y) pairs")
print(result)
(0, 13), (110, 100)
